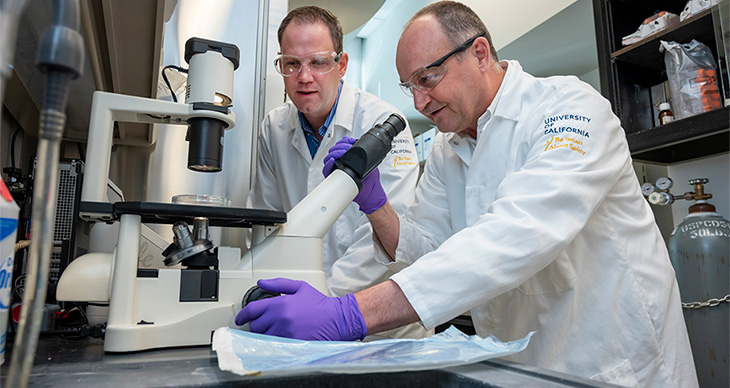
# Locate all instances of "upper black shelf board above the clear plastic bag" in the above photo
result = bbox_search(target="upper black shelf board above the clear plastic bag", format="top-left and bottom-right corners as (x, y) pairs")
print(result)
(611, 6), (717, 71)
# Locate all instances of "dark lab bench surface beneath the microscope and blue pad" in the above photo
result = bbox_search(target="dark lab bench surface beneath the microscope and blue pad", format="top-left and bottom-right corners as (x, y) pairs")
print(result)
(0, 337), (613, 388)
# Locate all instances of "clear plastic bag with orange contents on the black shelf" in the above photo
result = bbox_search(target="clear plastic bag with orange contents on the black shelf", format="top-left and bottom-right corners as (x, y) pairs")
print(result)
(659, 39), (722, 119)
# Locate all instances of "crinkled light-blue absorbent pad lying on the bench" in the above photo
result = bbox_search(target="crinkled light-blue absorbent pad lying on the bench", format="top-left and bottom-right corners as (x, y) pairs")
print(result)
(213, 326), (535, 375)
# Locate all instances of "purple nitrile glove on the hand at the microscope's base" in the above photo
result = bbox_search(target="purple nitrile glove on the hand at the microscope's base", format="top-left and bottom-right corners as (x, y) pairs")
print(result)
(235, 278), (367, 341)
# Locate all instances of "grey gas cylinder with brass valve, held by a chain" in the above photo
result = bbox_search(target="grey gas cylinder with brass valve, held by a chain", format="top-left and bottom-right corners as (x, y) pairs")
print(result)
(669, 178), (730, 388)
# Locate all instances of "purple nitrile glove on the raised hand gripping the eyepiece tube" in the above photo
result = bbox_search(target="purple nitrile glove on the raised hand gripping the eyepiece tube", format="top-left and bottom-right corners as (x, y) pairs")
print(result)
(322, 136), (388, 214)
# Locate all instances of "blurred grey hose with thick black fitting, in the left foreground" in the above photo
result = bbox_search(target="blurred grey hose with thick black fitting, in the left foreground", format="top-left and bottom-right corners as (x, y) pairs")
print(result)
(7, 0), (84, 388)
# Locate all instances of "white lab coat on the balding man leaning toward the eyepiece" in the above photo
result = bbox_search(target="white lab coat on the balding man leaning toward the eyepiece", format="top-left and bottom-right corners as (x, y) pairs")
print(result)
(378, 61), (697, 387)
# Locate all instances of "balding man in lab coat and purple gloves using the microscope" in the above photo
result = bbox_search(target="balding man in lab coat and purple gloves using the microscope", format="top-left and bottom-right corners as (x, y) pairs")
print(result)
(236, 1), (698, 387)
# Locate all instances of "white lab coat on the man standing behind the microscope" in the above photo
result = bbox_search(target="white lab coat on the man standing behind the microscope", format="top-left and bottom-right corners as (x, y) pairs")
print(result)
(247, 83), (427, 338)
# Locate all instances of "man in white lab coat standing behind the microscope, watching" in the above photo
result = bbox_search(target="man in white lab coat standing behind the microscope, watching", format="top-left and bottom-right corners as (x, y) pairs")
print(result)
(247, 7), (428, 338)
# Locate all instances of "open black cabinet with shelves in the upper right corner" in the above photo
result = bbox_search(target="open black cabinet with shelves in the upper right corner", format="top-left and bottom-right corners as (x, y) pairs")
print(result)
(593, 0), (730, 163)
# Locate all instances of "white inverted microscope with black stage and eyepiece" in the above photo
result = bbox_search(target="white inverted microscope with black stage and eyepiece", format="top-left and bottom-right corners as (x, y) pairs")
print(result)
(57, 38), (405, 352)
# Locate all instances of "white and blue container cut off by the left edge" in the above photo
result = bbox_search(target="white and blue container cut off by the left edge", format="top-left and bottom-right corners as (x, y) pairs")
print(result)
(0, 179), (19, 365)
